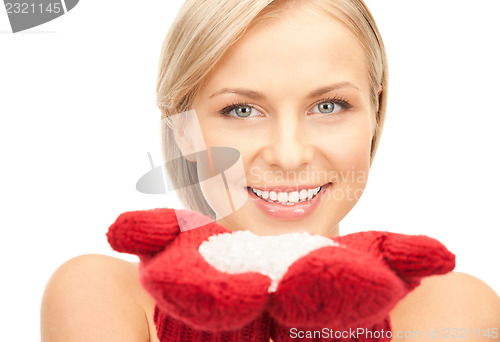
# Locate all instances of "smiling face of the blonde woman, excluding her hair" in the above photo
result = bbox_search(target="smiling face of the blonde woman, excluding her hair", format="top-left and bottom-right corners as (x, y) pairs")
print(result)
(188, 8), (375, 236)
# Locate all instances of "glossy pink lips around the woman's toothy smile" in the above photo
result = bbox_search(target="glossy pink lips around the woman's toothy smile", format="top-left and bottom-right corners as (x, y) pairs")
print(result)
(247, 183), (332, 221)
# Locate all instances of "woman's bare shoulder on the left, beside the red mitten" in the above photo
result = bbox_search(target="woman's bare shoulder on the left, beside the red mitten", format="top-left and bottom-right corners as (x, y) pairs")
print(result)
(41, 254), (156, 342)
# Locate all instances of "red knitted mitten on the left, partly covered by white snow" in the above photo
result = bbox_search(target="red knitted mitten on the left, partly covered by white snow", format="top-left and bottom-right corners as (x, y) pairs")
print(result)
(107, 209), (270, 342)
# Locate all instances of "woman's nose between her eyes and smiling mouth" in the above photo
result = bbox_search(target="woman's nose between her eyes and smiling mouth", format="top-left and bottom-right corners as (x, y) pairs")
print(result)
(262, 115), (314, 170)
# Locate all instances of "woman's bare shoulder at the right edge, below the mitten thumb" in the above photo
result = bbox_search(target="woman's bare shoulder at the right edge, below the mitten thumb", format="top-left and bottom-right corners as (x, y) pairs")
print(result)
(391, 272), (500, 342)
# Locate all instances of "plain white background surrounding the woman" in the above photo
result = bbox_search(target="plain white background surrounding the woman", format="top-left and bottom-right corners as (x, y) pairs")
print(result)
(0, 0), (500, 341)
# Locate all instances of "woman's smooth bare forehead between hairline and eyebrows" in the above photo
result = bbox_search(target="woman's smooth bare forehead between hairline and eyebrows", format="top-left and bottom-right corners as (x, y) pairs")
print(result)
(200, 6), (369, 99)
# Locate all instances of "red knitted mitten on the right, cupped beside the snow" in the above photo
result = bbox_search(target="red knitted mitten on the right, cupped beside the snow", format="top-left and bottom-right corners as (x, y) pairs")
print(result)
(268, 231), (455, 342)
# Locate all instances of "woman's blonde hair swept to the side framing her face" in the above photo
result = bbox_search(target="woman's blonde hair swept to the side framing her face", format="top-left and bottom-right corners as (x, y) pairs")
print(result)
(156, 0), (388, 218)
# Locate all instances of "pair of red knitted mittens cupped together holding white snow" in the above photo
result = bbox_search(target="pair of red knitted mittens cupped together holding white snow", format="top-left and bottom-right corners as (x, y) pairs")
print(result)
(107, 209), (455, 342)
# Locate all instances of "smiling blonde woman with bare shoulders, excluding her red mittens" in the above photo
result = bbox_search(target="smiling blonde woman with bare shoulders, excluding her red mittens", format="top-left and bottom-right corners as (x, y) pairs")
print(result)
(42, 0), (500, 341)
